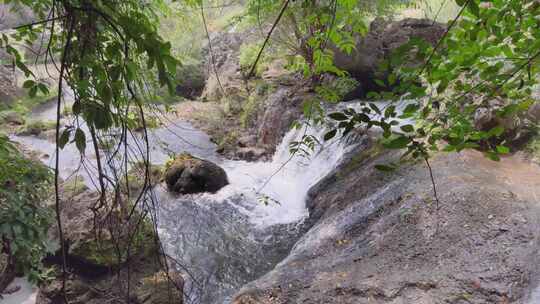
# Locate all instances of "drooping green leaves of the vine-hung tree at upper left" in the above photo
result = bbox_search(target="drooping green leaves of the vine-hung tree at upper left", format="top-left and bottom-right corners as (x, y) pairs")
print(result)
(7, 0), (178, 152)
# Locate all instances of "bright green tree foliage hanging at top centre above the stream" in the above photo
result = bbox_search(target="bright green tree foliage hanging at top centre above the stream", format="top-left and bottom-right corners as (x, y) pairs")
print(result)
(246, 0), (404, 82)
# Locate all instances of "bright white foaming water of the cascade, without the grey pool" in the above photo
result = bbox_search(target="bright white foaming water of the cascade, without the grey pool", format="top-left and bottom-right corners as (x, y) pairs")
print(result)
(206, 123), (350, 228)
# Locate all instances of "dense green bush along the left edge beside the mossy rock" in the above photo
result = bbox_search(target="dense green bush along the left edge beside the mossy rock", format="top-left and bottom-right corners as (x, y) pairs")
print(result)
(0, 135), (52, 282)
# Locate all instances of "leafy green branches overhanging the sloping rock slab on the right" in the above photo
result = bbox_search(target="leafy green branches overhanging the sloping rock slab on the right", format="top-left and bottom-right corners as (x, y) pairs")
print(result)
(324, 0), (540, 166)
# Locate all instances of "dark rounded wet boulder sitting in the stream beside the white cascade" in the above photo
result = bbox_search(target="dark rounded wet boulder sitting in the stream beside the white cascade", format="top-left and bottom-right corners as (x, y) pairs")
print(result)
(165, 153), (229, 194)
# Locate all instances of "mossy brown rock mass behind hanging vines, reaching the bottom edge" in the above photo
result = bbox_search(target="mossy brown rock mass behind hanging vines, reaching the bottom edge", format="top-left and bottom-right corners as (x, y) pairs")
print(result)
(36, 189), (184, 304)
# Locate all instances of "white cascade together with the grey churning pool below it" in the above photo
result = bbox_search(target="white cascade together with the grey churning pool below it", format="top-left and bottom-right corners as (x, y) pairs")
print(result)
(156, 120), (360, 304)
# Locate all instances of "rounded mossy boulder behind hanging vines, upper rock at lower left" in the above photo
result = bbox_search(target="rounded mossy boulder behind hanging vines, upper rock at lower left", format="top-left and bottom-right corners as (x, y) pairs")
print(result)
(45, 190), (158, 277)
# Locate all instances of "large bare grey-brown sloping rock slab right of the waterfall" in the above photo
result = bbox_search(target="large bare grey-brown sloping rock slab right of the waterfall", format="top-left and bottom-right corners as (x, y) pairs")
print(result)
(234, 137), (540, 304)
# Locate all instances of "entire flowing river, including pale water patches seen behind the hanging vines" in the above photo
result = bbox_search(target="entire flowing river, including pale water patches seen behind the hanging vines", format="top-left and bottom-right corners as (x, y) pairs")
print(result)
(2, 98), (362, 304)
